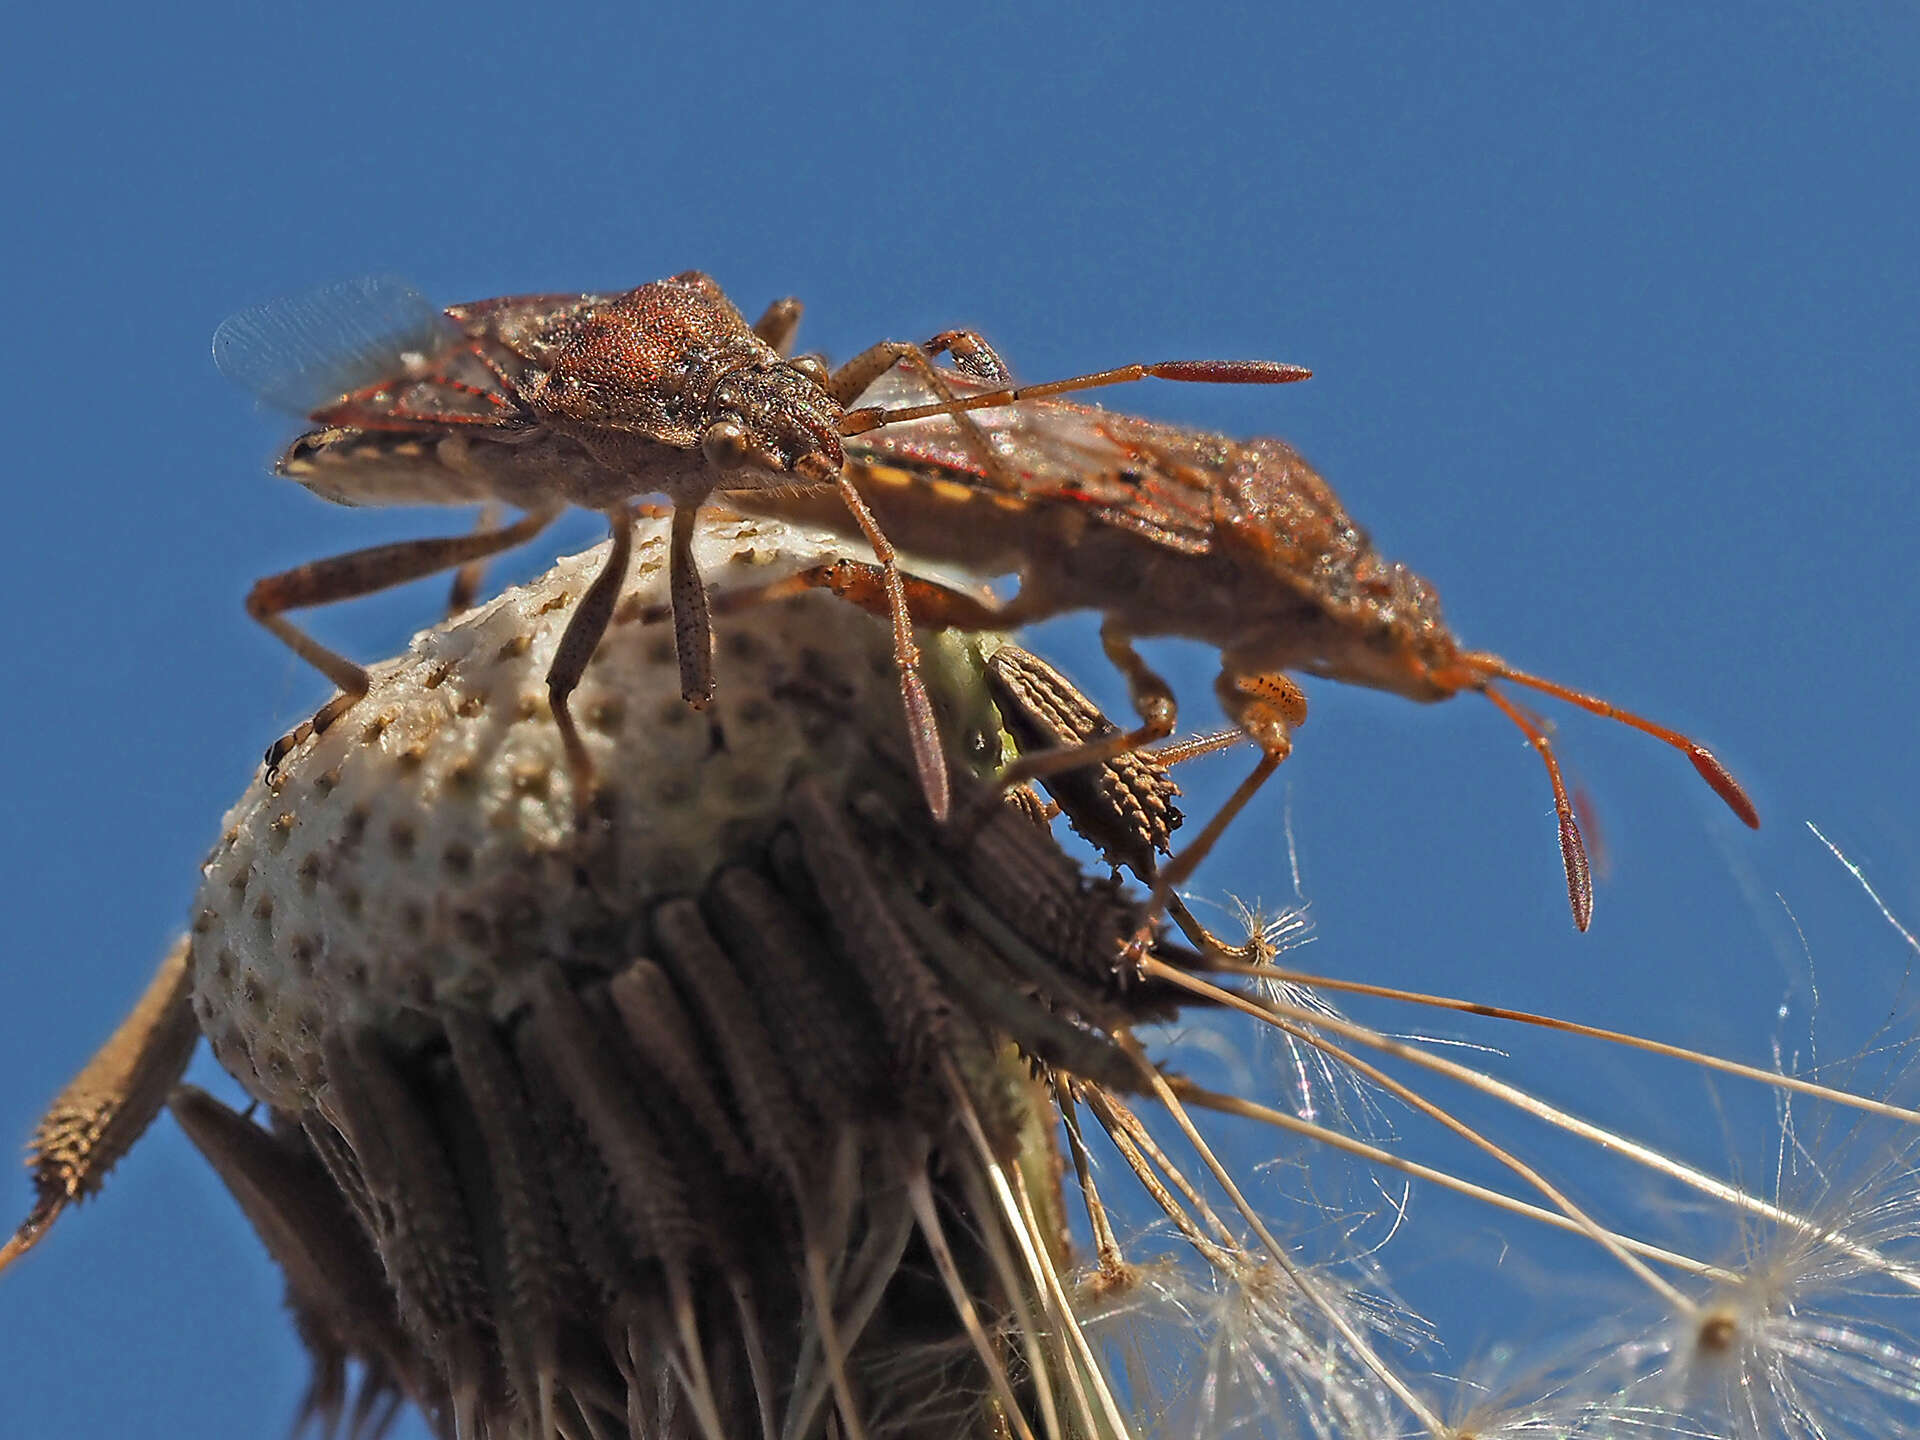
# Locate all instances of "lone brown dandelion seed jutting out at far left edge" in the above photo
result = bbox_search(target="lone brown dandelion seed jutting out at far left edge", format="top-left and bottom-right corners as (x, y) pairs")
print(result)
(0, 937), (200, 1269)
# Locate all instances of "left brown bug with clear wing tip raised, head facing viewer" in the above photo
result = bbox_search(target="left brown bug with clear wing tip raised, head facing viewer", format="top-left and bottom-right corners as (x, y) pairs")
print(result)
(213, 271), (1308, 818)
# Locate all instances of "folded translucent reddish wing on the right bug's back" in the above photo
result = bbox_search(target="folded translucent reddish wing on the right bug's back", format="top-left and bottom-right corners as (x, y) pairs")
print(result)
(847, 367), (1236, 553)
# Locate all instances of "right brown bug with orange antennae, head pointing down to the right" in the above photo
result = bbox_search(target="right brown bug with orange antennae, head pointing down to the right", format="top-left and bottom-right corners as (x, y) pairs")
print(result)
(735, 351), (1761, 929)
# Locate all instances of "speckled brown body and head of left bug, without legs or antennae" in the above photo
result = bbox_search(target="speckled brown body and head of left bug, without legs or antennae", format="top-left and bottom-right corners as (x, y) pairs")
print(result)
(276, 271), (841, 511)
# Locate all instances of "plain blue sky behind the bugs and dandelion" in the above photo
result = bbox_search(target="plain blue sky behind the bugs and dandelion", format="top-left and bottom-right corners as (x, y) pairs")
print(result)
(0, 0), (1920, 1440)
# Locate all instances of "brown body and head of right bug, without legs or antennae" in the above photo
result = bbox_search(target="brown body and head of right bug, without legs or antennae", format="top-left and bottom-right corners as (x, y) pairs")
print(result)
(837, 376), (1461, 701)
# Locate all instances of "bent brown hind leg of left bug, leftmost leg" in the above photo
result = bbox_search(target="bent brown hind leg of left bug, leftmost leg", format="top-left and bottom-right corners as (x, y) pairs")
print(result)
(246, 509), (559, 778)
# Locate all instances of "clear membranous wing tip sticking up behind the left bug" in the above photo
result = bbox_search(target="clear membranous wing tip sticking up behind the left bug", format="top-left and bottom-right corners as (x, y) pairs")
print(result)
(213, 275), (467, 417)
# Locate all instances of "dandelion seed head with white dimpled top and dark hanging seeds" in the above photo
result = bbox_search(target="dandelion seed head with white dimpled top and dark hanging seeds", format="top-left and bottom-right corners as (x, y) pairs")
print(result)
(142, 518), (1221, 1440)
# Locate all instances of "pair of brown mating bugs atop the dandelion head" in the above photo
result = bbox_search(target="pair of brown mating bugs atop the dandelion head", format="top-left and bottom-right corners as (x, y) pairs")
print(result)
(215, 273), (1759, 929)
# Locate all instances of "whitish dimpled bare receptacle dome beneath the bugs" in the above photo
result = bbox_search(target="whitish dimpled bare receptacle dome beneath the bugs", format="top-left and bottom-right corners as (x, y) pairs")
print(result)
(192, 518), (998, 1110)
